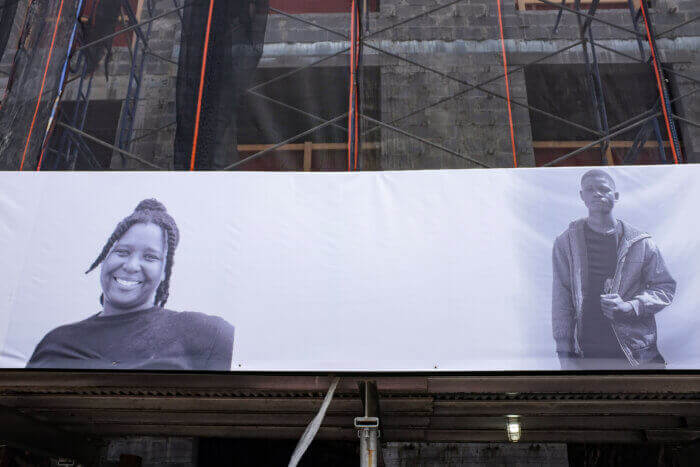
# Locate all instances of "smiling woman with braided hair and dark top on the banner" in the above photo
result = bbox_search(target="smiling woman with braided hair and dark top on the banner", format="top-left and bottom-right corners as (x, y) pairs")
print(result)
(27, 199), (233, 370)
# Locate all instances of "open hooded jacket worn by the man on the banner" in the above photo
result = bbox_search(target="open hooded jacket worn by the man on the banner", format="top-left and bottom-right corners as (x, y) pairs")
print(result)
(552, 219), (676, 367)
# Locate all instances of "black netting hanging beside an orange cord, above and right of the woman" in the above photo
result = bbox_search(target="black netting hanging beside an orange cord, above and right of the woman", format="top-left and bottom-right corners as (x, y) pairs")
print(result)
(174, 0), (269, 169)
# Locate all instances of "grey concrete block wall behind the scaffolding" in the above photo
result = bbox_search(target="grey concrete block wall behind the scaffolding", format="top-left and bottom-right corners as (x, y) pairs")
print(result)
(0, 0), (700, 169)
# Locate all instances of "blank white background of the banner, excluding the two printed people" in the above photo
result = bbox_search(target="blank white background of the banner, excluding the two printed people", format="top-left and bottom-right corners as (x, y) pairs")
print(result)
(0, 165), (700, 371)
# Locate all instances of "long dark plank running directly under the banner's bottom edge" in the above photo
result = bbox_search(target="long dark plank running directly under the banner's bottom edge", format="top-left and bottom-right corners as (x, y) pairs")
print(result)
(0, 370), (700, 397)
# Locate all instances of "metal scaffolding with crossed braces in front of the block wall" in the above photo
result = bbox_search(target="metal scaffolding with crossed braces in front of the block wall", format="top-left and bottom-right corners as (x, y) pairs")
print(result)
(0, 0), (699, 170)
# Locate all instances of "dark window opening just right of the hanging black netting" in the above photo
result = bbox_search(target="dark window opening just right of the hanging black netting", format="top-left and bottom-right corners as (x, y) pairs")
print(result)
(238, 67), (380, 171)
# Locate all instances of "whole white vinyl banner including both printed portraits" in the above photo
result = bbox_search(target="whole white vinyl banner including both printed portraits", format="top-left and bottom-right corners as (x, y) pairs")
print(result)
(0, 165), (700, 372)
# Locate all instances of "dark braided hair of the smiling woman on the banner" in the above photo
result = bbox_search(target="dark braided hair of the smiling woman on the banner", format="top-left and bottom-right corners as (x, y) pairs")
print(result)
(85, 199), (180, 308)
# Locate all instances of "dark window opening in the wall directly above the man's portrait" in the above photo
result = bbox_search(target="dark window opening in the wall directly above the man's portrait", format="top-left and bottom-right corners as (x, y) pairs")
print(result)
(525, 64), (673, 166)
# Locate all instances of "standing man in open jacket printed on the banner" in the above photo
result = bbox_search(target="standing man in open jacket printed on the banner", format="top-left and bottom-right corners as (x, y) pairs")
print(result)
(552, 169), (676, 370)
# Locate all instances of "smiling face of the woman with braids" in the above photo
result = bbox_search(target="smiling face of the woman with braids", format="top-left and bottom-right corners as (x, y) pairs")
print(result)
(100, 224), (166, 313)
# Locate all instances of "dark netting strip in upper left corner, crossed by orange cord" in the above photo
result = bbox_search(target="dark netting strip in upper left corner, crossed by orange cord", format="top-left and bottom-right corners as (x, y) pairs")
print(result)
(0, 0), (78, 170)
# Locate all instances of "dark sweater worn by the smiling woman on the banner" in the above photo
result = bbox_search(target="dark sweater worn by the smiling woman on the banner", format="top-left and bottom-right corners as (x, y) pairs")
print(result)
(27, 307), (233, 371)
